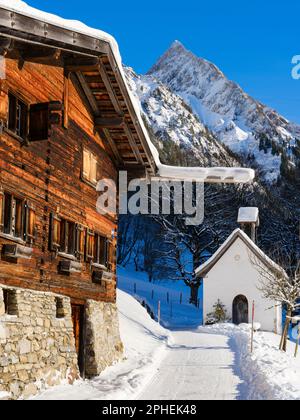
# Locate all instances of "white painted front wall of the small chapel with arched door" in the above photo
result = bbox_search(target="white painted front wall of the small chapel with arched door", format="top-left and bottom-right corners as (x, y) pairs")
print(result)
(203, 238), (282, 334)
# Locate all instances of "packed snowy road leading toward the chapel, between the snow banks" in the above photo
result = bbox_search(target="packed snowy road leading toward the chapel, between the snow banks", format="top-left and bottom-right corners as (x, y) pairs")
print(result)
(138, 331), (242, 400)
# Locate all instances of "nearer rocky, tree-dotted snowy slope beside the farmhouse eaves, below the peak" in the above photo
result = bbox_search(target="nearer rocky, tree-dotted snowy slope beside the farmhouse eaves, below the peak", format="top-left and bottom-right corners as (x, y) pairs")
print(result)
(125, 67), (240, 166)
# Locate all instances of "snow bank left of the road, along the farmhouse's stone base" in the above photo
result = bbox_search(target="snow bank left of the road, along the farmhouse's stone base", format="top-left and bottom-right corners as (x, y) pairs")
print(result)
(34, 291), (171, 400)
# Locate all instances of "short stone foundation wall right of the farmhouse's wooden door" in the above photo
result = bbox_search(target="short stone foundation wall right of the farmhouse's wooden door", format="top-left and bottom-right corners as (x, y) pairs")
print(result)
(85, 300), (123, 377)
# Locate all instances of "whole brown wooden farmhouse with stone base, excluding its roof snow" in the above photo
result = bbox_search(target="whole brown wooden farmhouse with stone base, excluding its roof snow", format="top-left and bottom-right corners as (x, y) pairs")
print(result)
(0, 2), (156, 398)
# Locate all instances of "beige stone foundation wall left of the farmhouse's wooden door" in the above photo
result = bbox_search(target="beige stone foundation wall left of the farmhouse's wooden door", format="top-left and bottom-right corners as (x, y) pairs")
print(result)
(0, 285), (79, 399)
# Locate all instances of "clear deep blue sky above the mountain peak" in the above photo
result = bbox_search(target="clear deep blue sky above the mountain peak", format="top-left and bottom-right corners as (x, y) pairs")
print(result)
(27, 0), (300, 124)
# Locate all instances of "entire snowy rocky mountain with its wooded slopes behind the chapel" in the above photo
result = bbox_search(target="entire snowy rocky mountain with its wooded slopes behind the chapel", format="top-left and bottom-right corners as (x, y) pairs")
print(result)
(125, 42), (300, 255)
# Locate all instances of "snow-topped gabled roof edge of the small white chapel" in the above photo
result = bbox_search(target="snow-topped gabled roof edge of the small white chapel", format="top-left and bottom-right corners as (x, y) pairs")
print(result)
(195, 229), (287, 277)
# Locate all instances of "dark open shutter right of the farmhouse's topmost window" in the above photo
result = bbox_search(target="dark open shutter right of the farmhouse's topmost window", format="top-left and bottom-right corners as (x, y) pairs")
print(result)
(29, 102), (62, 141)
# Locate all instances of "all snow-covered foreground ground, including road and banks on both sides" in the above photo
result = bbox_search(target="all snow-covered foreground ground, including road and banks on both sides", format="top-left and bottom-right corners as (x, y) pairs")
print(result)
(31, 282), (300, 400)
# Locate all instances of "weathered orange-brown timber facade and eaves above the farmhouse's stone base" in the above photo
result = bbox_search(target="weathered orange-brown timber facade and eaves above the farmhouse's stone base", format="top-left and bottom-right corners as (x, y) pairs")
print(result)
(0, 10), (155, 303)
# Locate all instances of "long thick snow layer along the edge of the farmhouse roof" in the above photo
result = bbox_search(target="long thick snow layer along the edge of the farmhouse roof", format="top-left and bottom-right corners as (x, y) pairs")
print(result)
(0, 0), (255, 183)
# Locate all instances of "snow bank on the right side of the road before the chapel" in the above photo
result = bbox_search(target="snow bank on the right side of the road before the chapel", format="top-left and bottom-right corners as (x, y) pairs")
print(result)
(199, 324), (300, 400)
